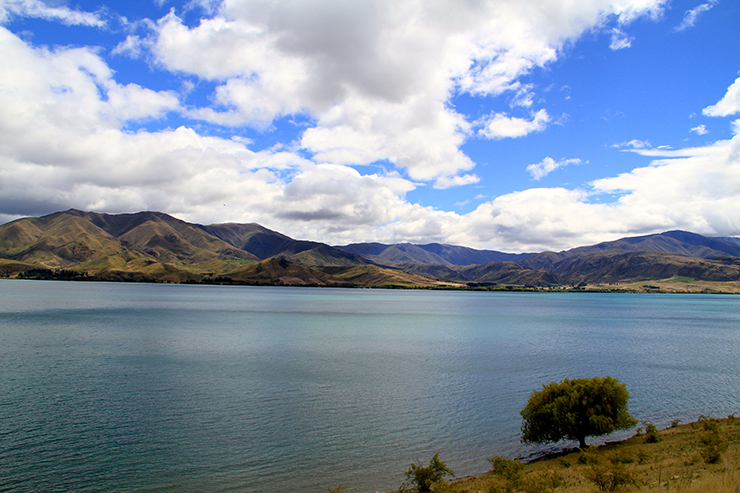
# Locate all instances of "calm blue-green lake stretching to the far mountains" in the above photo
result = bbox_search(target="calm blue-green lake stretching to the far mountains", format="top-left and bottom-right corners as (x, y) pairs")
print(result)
(0, 280), (740, 493)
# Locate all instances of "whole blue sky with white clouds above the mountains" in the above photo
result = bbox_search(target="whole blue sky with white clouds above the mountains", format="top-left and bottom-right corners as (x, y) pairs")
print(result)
(0, 0), (740, 248)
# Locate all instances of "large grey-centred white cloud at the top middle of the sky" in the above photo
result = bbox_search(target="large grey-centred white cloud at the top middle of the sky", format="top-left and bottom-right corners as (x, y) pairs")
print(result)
(146, 0), (664, 182)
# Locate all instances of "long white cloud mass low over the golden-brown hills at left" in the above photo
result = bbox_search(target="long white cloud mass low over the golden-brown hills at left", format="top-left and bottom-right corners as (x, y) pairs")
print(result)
(0, 28), (416, 244)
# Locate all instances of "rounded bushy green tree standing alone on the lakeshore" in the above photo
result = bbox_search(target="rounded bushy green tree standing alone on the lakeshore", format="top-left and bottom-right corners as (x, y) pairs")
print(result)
(521, 377), (637, 448)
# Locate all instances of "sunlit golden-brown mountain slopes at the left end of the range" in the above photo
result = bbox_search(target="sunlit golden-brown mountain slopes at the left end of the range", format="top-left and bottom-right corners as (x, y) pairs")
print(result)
(0, 210), (257, 275)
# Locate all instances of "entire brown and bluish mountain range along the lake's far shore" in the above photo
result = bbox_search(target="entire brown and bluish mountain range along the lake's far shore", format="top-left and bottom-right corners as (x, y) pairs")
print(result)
(0, 210), (740, 287)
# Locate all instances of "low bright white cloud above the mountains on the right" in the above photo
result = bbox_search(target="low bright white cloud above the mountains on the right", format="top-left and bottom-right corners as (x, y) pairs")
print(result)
(445, 129), (740, 251)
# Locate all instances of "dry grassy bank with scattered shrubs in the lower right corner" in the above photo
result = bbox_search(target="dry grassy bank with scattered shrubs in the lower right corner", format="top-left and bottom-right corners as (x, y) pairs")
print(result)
(398, 415), (740, 493)
